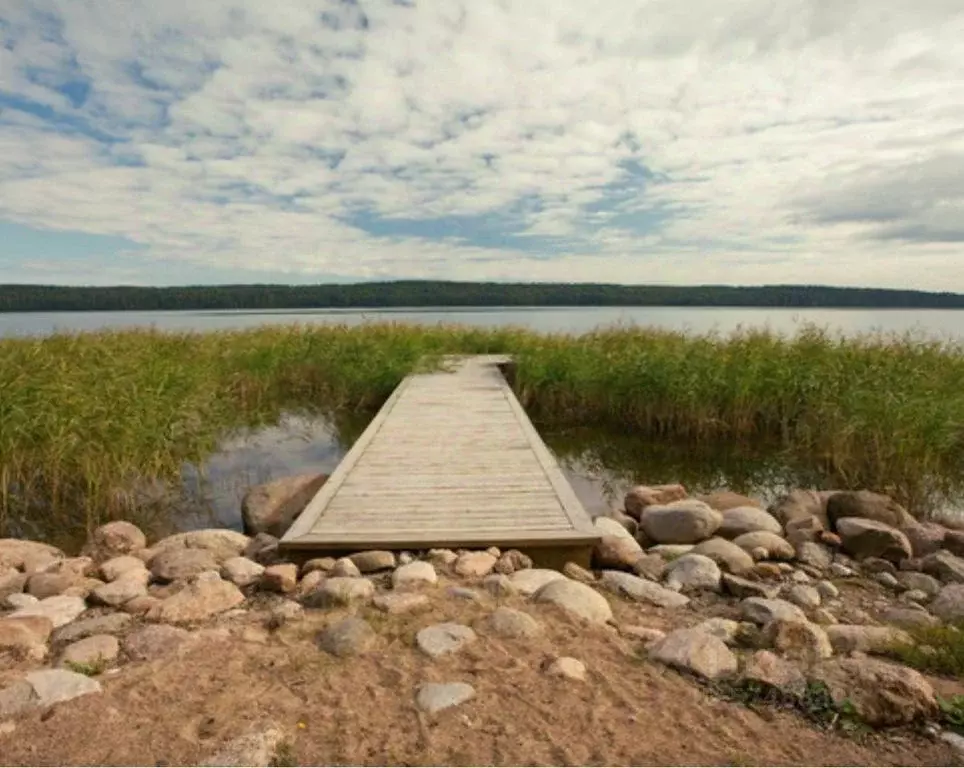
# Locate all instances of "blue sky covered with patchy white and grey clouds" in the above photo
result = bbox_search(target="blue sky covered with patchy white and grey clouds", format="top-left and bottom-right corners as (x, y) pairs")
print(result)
(0, 0), (964, 292)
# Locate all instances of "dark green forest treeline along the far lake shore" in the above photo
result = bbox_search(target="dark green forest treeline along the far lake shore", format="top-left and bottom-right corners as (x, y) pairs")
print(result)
(0, 280), (964, 312)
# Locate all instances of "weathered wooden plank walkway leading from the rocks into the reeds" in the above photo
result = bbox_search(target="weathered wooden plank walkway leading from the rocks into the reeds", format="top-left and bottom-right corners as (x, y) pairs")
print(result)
(281, 356), (599, 561)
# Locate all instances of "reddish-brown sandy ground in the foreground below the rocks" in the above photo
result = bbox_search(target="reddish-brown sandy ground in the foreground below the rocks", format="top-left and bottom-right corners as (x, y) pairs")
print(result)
(0, 598), (956, 765)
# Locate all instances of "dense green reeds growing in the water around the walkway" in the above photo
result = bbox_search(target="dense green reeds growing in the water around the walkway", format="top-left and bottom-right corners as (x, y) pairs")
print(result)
(0, 324), (964, 532)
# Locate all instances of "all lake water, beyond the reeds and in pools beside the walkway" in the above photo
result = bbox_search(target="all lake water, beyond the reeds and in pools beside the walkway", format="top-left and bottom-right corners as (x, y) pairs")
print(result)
(0, 307), (964, 549)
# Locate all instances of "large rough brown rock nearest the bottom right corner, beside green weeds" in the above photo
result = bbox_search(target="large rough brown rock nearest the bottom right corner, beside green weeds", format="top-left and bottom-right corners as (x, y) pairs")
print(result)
(810, 657), (938, 727)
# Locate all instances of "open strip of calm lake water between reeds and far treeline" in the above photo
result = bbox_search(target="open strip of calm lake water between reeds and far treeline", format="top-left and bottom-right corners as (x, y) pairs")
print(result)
(0, 307), (964, 340)
